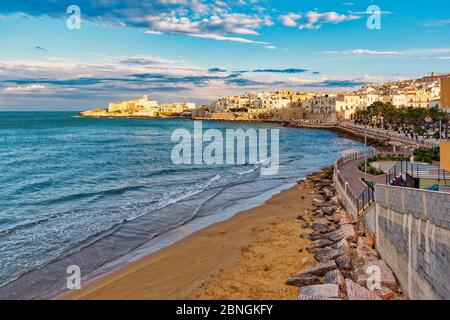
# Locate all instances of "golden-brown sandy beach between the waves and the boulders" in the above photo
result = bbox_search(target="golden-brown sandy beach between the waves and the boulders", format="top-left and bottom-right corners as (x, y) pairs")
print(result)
(58, 170), (324, 299)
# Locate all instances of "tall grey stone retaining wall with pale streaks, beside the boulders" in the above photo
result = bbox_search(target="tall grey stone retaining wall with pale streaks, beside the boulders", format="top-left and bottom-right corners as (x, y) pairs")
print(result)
(363, 185), (450, 299)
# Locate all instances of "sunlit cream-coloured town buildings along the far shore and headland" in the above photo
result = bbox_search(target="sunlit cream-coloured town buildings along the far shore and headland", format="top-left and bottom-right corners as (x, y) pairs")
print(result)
(80, 73), (450, 123)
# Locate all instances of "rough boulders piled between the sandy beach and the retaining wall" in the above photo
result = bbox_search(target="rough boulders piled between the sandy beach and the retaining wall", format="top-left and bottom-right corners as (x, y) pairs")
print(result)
(286, 168), (405, 300)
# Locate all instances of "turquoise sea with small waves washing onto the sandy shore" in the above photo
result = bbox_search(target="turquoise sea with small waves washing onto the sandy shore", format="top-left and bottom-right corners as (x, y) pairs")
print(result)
(0, 112), (361, 298)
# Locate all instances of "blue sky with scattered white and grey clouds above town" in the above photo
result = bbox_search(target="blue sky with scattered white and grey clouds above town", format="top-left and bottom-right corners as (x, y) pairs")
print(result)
(0, 0), (450, 111)
